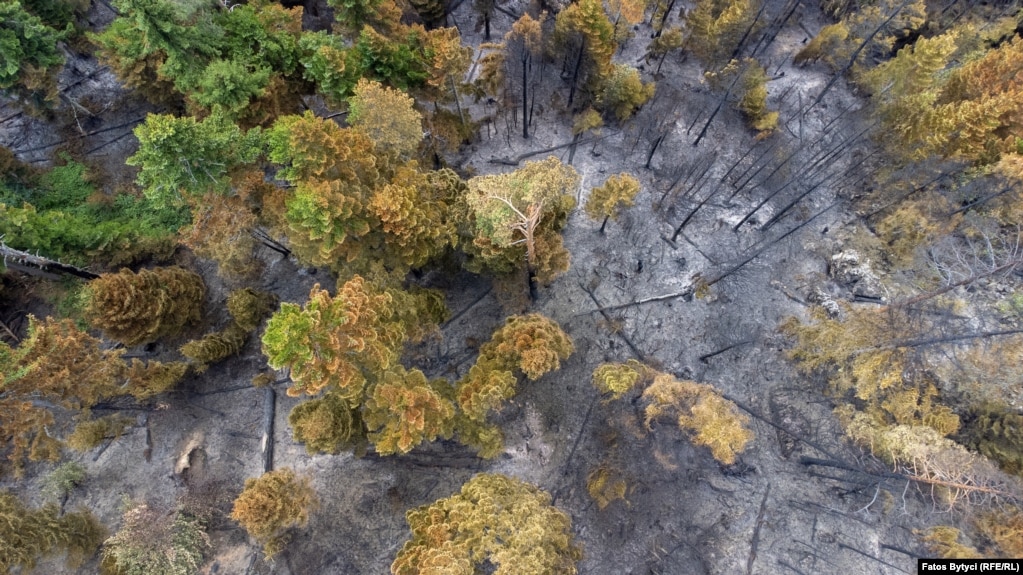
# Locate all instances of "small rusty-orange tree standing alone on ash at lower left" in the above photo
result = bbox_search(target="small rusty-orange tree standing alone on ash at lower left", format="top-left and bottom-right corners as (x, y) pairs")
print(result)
(231, 468), (319, 558)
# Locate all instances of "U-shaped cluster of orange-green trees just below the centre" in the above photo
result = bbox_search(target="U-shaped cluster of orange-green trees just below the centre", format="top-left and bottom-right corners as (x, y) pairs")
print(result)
(263, 276), (572, 456)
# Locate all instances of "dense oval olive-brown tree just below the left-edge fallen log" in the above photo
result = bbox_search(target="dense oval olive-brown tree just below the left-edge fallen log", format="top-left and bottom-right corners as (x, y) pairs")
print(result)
(86, 266), (206, 346)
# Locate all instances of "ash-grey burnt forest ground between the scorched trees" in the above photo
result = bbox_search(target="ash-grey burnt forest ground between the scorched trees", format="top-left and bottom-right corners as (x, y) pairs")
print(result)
(0, 2), (977, 575)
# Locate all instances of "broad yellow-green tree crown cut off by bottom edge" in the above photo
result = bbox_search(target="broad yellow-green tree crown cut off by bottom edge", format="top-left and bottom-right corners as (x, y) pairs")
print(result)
(391, 474), (582, 575)
